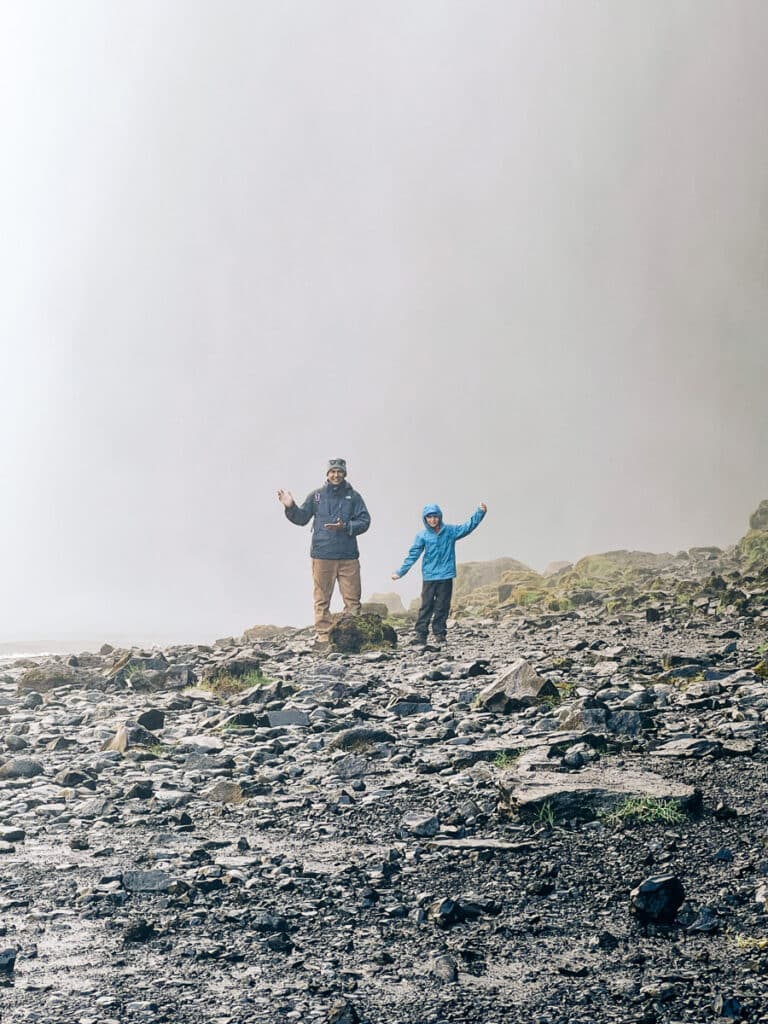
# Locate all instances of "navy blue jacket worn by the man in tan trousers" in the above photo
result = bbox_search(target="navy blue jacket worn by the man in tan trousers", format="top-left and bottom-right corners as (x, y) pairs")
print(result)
(286, 480), (371, 560)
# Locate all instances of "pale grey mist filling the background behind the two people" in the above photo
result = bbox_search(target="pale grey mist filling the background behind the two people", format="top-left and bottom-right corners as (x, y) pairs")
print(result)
(0, 0), (768, 643)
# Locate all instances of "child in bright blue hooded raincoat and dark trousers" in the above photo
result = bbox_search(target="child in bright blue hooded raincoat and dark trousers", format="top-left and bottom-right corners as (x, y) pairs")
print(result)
(392, 502), (487, 643)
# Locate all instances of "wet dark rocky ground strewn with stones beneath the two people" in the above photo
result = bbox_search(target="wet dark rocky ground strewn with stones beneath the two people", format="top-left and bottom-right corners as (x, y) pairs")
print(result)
(0, 606), (768, 1024)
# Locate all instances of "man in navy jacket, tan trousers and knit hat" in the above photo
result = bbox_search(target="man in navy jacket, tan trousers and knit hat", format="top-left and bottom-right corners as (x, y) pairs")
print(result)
(278, 459), (371, 644)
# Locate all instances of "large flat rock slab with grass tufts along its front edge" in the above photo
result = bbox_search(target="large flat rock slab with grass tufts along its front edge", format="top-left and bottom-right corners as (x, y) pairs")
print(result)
(504, 762), (701, 818)
